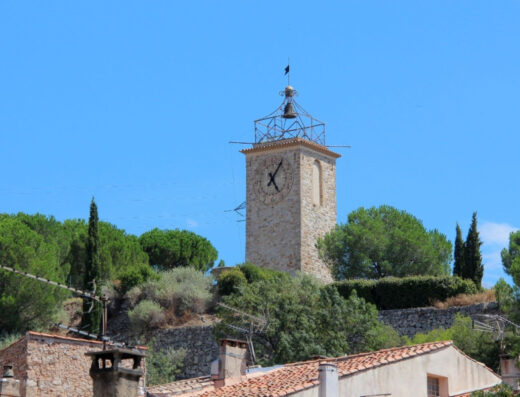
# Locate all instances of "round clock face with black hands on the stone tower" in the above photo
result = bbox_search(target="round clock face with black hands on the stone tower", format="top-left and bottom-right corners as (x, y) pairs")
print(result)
(255, 156), (293, 204)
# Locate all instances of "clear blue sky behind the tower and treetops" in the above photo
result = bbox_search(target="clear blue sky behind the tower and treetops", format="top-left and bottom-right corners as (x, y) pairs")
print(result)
(0, 0), (520, 285)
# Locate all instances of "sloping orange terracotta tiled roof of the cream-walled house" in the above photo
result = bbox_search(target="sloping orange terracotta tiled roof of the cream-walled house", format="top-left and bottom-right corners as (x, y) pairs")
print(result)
(201, 341), (453, 397)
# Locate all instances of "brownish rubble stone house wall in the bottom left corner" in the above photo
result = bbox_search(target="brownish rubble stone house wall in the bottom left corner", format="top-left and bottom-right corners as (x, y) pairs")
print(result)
(0, 332), (144, 397)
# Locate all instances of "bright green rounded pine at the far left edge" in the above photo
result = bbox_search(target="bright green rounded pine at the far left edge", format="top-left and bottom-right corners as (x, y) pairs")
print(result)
(0, 215), (69, 333)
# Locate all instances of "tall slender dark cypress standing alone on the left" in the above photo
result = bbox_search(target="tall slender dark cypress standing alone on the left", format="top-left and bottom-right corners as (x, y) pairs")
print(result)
(81, 197), (101, 333)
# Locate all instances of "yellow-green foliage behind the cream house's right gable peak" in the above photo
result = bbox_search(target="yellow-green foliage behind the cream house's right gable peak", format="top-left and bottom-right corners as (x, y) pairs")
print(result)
(408, 314), (500, 371)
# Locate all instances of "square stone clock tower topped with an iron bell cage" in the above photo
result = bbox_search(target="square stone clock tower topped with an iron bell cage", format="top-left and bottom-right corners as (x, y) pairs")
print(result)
(242, 86), (340, 282)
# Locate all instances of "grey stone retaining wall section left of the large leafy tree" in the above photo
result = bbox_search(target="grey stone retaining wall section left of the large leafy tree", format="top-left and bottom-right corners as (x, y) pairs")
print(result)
(150, 325), (218, 379)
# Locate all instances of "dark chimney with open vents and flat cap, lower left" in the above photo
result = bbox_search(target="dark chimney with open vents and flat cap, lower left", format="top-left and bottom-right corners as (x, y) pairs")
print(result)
(85, 349), (145, 397)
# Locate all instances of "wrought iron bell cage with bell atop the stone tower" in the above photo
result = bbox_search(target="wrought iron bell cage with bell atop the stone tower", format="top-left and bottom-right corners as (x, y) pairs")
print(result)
(255, 85), (325, 146)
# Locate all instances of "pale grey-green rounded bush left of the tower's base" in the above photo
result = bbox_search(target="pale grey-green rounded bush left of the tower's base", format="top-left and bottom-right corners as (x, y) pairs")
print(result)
(131, 267), (213, 316)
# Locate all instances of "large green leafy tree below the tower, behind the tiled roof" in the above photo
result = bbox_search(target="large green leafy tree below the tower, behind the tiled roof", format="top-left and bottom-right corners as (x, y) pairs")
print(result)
(216, 275), (399, 364)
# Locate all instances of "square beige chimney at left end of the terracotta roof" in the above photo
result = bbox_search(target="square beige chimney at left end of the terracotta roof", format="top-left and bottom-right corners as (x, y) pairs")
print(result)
(212, 339), (247, 387)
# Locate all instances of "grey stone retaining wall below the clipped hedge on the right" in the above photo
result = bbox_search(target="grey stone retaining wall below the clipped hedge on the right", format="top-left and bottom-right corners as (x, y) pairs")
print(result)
(379, 302), (497, 337)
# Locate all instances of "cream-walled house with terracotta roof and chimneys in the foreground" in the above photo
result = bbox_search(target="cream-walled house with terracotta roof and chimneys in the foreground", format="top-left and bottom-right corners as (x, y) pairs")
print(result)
(147, 341), (502, 397)
